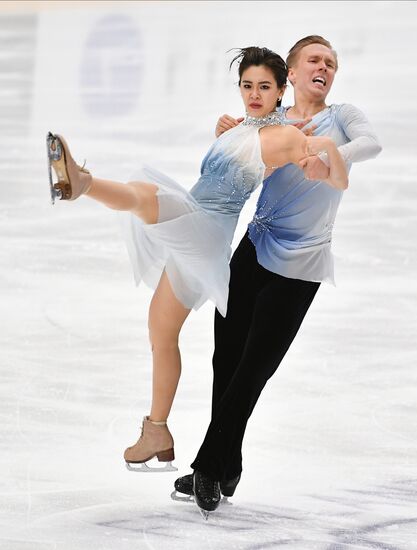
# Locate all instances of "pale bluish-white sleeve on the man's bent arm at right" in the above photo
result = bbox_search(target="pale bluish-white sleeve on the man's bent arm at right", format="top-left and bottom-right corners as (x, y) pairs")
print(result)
(319, 103), (382, 165)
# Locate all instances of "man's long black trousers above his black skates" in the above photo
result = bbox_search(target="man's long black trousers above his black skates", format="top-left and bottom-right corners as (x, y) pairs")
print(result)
(191, 234), (320, 481)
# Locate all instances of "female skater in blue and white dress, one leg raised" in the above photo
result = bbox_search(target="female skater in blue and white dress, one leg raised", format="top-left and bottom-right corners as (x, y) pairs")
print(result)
(47, 47), (348, 471)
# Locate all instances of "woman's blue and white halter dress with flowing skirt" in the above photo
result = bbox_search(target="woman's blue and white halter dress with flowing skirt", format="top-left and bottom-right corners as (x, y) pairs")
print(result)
(125, 113), (281, 316)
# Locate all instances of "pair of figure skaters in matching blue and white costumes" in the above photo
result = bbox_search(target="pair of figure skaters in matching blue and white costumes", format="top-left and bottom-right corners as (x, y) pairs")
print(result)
(47, 35), (381, 517)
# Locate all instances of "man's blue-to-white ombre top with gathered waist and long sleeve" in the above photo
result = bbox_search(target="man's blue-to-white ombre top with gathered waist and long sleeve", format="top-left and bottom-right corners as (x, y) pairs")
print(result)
(249, 104), (381, 284)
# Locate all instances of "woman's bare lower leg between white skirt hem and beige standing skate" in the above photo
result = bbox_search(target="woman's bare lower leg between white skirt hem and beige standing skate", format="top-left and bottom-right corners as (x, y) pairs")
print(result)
(149, 272), (190, 422)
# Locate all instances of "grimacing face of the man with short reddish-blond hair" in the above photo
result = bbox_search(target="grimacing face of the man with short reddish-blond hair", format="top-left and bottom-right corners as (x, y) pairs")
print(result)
(288, 44), (336, 100)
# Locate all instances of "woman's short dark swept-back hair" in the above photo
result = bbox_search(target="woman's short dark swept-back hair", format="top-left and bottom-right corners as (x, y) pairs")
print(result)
(229, 46), (288, 107)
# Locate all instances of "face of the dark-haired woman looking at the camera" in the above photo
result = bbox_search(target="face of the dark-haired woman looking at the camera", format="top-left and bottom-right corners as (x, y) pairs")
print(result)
(240, 65), (285, 117)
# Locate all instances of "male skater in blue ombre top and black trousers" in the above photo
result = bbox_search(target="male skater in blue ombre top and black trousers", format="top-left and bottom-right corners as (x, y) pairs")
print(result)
(175, 36), (381, 515)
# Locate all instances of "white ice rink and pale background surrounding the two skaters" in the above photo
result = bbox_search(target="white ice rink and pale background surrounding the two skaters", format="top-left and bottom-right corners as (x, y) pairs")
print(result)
(0, 2), (417, 550)
